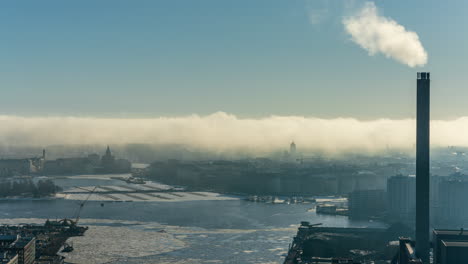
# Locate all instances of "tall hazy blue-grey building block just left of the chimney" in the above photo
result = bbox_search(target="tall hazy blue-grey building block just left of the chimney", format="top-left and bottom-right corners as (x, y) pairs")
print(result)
(387, 175), (416, 222)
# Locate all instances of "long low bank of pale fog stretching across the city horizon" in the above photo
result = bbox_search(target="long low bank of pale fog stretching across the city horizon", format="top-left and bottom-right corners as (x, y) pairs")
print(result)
(0, 112), (468, 155)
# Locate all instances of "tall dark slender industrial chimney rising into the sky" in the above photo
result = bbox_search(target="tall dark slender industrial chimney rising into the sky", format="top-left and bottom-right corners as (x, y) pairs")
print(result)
(416, 72), (430, 264)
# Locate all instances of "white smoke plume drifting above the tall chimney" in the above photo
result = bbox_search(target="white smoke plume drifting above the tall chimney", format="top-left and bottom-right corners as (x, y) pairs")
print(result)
(343, 2), (428, 67)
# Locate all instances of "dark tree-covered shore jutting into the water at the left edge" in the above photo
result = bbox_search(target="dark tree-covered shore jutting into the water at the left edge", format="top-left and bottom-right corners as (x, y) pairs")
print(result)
(0, 179), (61, 197)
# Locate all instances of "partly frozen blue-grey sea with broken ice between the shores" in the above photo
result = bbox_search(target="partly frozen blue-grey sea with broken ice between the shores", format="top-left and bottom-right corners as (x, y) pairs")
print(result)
(0, 175), (383, 264)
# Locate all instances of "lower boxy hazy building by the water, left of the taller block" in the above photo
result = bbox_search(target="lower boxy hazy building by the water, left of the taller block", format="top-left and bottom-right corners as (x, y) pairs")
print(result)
(348, 190), (386, 218)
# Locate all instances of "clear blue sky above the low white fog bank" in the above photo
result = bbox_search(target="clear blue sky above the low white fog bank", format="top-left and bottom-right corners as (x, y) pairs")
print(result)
(0, 0), (468, 119)
